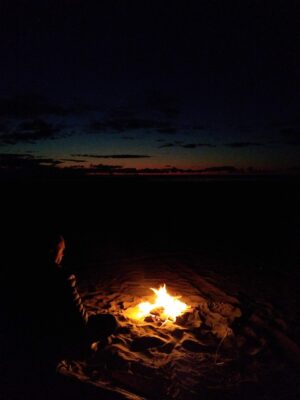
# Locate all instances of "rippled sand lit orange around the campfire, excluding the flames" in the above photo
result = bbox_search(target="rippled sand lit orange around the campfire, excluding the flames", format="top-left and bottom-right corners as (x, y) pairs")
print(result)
(59, 257), (298, 400)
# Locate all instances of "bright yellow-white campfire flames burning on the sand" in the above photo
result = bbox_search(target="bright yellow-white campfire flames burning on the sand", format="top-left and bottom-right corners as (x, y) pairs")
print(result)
(125, 284), (190, 322)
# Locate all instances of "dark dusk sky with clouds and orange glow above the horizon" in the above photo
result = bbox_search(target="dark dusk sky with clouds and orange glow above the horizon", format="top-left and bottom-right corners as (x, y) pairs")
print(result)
(0, 0), (300, 176)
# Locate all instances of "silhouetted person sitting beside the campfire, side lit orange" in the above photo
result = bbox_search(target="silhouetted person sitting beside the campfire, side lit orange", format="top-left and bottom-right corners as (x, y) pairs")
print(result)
(39, 236), (117, 366)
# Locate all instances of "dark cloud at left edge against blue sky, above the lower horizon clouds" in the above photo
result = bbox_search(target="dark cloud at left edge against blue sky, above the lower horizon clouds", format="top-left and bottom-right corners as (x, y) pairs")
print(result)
(0, 119), (62, 145)
